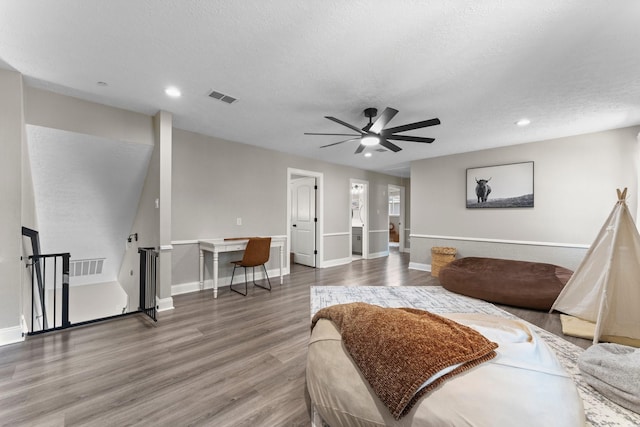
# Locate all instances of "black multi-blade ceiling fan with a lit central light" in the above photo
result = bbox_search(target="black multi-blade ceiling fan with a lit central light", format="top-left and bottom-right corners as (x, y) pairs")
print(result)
(305, 107), (440, 154)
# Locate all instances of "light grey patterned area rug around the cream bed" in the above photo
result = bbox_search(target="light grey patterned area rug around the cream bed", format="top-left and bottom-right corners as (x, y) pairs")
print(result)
(310, 286), (640, 427)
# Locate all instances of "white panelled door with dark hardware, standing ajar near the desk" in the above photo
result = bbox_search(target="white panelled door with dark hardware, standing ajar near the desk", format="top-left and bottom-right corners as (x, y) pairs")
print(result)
(291, 177), (316, 267)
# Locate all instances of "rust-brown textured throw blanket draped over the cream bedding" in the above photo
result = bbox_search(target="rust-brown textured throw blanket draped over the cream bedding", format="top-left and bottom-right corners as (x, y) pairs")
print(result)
(311, 302), (498, 419)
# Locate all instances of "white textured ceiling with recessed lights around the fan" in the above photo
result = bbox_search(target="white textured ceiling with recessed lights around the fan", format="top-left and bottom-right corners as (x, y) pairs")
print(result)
(0, 0), (640, 175)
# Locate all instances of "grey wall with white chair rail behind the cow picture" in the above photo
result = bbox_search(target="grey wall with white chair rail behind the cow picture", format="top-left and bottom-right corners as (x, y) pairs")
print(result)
(411, 127), (640, 269)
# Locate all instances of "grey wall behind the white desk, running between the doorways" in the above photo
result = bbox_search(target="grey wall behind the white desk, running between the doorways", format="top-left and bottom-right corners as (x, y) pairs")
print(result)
(172, 129), (403, 286)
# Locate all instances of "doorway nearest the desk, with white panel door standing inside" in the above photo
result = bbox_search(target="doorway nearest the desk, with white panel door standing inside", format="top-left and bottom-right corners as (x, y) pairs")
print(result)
(287, 168), (323, 267)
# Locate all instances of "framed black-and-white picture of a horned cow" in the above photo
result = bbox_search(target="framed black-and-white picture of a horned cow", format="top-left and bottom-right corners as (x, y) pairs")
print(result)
(466, 162), (533, 209)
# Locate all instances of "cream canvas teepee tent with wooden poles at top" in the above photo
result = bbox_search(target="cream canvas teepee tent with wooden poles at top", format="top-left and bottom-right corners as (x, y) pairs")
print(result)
(551, 188), (640, 344)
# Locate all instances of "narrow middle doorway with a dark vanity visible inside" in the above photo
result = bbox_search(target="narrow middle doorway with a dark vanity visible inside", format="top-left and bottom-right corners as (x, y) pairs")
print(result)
(350, 179), (369, 261)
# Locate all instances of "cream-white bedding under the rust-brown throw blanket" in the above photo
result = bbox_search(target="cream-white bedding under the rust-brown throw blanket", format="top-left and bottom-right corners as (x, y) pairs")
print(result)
(307, 314), (585, 427)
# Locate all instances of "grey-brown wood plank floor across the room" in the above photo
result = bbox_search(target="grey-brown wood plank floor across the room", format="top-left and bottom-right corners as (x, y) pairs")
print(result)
(0, 252), (589, 427)
